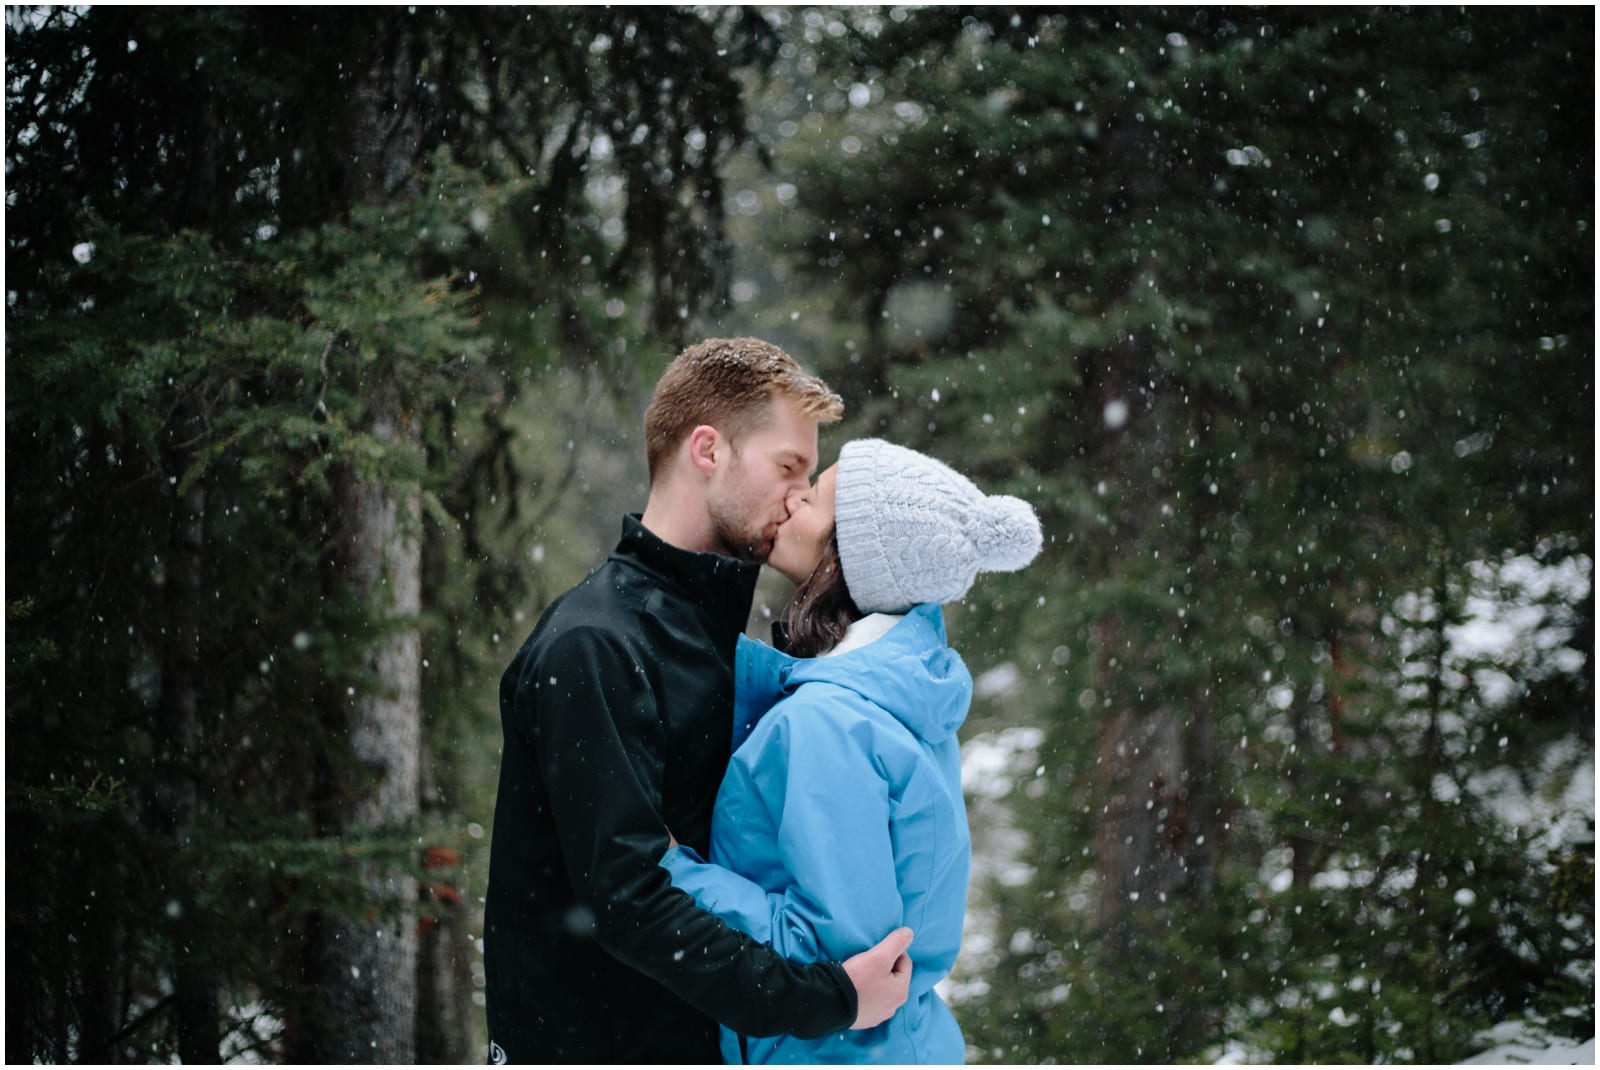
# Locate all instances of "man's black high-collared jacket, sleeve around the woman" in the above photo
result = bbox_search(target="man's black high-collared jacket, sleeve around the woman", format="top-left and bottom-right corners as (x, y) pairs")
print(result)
(483, 517), (856, 1062)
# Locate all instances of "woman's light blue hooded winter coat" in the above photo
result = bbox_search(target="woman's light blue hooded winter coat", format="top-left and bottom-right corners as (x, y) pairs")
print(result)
(662, 605), (973, 1064)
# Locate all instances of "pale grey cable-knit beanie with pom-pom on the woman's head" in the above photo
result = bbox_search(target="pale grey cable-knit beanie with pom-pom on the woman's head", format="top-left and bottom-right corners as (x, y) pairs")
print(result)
(834, 438), (1043, 613)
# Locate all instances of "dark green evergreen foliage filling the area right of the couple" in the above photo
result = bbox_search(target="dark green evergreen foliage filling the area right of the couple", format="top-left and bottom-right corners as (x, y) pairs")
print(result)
(768, 8), (1594, 1062)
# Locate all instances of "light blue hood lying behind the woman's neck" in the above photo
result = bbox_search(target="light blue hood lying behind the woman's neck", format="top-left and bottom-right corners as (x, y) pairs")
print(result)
(733, 605), (973, 749)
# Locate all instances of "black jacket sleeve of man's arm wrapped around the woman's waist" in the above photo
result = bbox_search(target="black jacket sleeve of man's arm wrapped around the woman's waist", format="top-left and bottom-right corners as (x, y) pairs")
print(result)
(517, 629), (859, 1038)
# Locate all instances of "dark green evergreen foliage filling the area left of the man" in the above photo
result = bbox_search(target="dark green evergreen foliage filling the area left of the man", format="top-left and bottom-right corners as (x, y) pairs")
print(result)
(6, 8), (773, 1062)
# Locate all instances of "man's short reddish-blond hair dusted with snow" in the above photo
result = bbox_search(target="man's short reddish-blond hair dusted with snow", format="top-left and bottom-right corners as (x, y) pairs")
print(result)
(645, 337), (845, 483)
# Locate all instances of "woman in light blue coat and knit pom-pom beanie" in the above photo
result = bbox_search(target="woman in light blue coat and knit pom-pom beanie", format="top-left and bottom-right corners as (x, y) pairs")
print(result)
(662, 438), (1042, 1064)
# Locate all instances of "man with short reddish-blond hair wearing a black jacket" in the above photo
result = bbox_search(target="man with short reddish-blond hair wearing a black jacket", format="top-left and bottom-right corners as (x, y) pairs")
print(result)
(485, 339), (910, 1062)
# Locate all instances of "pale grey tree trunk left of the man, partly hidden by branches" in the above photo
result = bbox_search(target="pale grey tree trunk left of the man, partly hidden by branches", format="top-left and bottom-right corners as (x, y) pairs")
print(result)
(294, 29), (422, 1064)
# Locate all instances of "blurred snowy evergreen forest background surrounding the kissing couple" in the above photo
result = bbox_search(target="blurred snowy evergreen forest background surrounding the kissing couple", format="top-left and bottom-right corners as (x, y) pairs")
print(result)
(5, 6), (1595, 1064)
